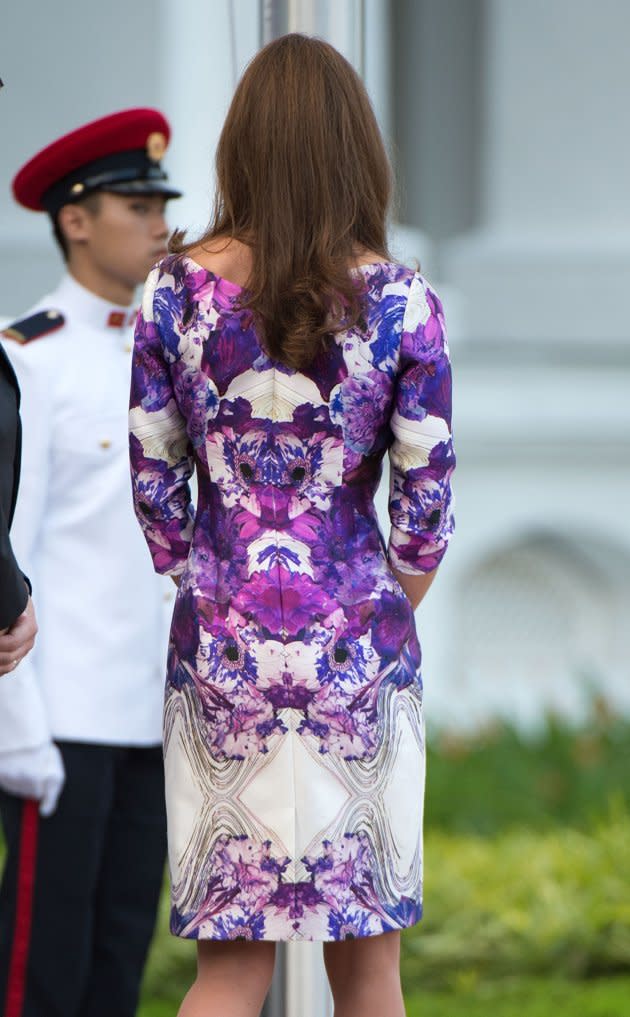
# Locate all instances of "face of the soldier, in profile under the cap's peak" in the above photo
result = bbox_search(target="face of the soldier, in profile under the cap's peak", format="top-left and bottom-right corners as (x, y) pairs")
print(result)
(78, 192), (168, 287)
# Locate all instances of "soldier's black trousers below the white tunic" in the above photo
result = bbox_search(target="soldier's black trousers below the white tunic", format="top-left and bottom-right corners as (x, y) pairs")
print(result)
(0, 741), (166, 1017)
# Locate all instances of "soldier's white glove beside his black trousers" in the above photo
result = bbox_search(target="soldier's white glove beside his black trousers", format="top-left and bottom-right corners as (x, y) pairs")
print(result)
(0, 741), (65, 816)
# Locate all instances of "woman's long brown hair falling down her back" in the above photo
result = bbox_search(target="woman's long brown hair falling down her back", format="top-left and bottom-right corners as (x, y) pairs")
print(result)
(170, 34), (392, 368)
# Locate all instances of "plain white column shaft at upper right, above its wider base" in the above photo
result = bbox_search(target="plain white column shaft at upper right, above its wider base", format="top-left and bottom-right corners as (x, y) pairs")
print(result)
(482, 0), (630, 239)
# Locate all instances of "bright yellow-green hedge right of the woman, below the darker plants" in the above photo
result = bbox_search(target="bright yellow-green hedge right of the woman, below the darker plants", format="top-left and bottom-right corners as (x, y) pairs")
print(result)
(403, 810), (630, 988)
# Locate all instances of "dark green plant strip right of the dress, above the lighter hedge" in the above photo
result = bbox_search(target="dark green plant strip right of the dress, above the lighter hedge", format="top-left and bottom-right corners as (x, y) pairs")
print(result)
(425, 704), (630, 838)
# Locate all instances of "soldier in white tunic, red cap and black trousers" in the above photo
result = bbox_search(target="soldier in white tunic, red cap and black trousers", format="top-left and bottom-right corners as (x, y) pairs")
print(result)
(0, 109), (179, 1017)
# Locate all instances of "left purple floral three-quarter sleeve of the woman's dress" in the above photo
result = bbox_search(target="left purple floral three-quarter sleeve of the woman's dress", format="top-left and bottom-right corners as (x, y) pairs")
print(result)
(129, 268), (193, 576)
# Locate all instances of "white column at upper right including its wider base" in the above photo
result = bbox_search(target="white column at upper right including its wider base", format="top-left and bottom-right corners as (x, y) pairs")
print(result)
(443, 0), (630, 343)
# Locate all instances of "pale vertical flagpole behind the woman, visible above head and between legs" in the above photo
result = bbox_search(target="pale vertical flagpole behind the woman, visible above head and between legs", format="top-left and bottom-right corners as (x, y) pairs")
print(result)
(261, 7), (365, 1017)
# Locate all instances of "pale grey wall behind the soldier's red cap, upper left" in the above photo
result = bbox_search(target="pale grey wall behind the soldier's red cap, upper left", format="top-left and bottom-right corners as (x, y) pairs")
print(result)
(0, 0), (161, 318)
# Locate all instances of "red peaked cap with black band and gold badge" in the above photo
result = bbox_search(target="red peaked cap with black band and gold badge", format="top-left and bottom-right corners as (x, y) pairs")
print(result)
(13, 108), (181, 216)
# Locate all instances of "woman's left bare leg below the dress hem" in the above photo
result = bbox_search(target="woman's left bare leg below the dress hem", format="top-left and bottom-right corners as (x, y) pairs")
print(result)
(177, 940), (276, 1017)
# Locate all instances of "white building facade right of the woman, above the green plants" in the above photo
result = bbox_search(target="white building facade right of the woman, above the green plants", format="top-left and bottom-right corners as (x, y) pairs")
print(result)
(396, 0), (630, 729)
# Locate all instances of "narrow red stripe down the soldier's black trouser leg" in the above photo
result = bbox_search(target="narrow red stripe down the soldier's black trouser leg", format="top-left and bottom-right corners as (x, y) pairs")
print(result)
(4, 798), (40, 1017)
